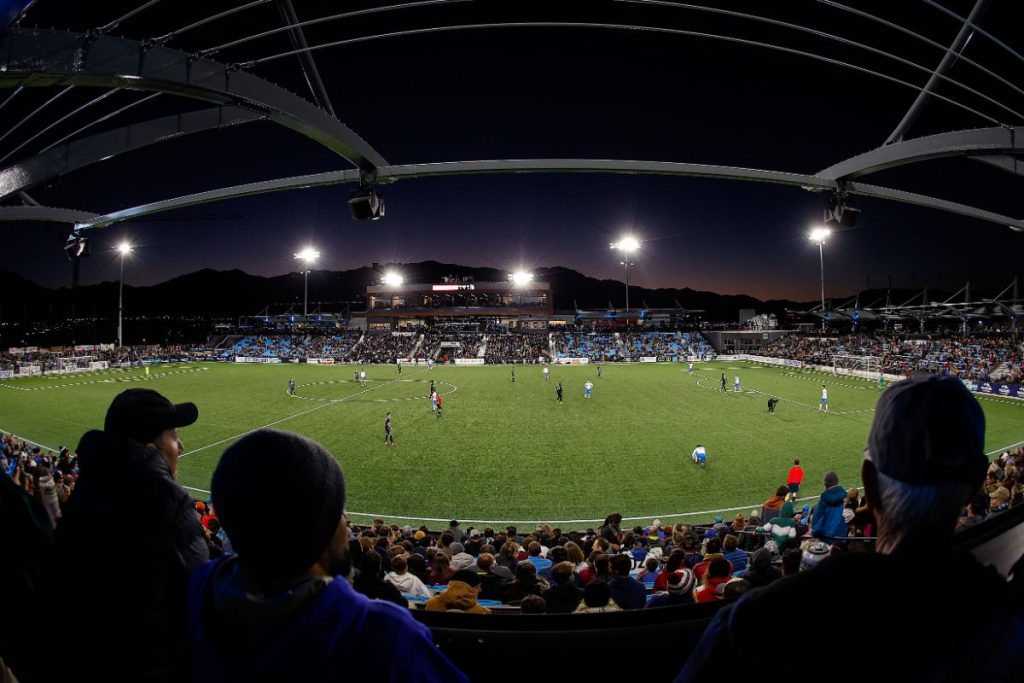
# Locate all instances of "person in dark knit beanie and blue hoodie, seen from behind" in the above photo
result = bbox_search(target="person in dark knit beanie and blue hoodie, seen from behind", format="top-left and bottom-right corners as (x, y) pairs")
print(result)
(188, 429), (467, 683)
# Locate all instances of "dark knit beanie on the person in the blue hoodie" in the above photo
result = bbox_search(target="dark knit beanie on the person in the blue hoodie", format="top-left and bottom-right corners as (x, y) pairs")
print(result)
(210, 429), (345, 581)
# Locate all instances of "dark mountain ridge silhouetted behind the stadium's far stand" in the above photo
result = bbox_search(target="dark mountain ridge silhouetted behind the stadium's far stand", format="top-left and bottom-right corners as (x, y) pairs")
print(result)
(6, 261), (921, 322)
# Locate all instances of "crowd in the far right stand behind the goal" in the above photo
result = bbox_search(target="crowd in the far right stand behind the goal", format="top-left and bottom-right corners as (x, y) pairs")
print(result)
(762, 333), (1024, 384)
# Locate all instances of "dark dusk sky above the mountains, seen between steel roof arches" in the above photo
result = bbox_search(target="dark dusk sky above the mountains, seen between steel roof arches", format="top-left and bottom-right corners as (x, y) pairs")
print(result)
(0, 0), (1024, 300)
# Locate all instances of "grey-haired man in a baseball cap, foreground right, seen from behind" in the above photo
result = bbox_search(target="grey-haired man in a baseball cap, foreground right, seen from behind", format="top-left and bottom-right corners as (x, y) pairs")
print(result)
(676, 376), (1024, 683)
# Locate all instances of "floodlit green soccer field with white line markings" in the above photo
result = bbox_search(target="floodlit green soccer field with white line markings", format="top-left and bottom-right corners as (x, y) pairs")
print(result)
(0, 360), (1024, 527)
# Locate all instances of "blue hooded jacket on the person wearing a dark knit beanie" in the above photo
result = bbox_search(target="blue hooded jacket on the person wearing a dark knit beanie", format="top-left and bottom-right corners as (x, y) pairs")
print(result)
(188, 557), (467, 683)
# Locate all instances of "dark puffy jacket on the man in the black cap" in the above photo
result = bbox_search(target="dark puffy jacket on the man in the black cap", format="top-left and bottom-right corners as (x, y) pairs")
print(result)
(51, 430), (209, 681)
